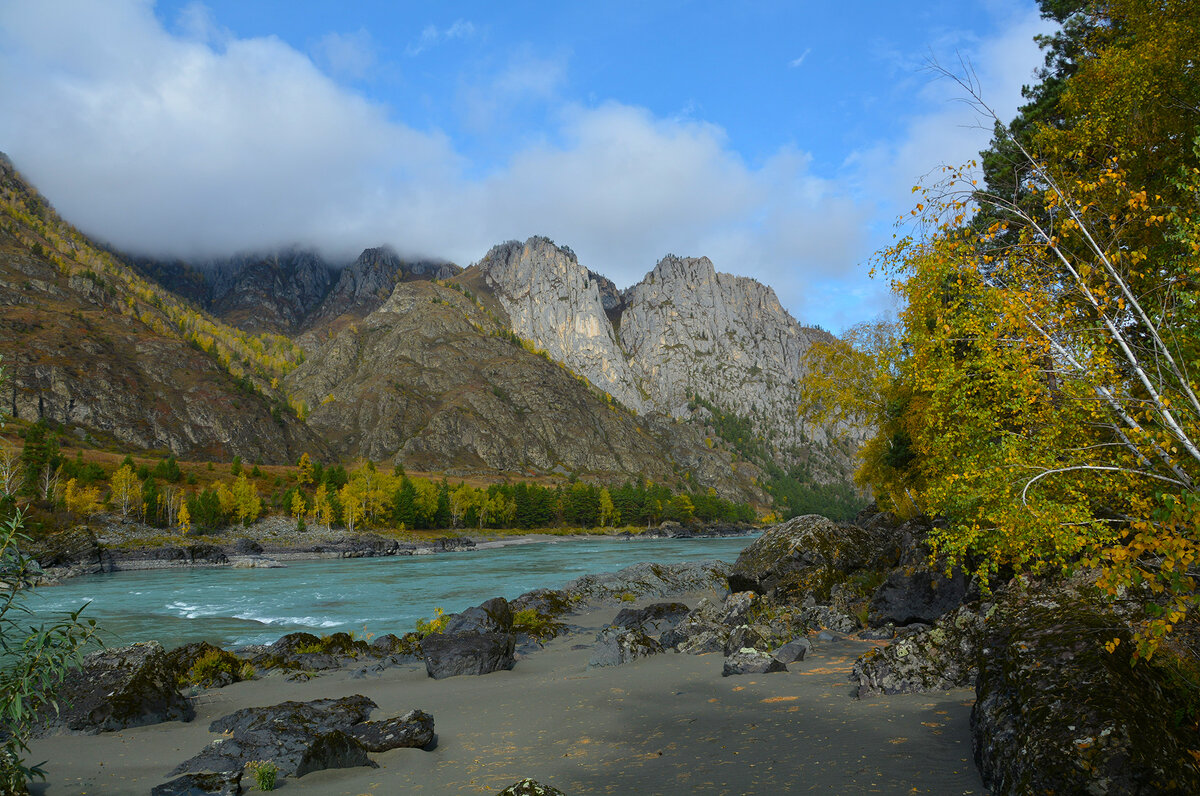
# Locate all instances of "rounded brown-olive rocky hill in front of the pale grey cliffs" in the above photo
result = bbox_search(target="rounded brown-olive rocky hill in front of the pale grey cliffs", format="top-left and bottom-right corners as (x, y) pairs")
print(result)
(287, 282), (764, 502)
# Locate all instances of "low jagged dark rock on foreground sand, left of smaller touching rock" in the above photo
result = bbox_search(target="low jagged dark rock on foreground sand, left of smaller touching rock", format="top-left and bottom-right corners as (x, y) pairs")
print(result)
(172, 694), (376, 777)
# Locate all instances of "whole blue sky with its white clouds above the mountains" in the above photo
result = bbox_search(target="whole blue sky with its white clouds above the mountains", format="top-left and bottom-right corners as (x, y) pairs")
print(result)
(0, 0), (1049, 330)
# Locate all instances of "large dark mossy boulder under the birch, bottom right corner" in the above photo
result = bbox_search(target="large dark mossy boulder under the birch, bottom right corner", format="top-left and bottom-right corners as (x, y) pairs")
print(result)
(971, 587), (1200, 796)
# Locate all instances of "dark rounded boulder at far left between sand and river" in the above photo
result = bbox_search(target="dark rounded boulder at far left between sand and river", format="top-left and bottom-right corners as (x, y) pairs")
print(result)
(38, 641), (194, 735)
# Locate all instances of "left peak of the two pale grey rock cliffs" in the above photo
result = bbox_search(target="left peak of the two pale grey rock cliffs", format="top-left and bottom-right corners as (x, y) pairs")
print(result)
(476, 238), (647, 412)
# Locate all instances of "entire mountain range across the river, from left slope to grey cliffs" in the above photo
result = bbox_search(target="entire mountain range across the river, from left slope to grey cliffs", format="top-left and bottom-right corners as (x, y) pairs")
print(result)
(0, 152), (853, 504)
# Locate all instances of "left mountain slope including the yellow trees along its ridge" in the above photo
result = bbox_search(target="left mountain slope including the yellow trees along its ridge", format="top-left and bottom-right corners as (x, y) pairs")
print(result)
(0, 156), (325, 462)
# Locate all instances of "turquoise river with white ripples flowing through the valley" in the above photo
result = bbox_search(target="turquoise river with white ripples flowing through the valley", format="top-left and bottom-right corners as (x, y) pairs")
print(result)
(26, 537), (754, 648)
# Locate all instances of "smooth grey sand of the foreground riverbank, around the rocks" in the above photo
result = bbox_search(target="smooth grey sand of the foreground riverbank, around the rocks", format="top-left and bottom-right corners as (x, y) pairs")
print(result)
(30, 600), (985, 796)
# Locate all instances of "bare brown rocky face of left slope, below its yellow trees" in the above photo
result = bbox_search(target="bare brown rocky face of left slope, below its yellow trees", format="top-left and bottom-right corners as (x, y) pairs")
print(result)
(0, 190), (328, 463)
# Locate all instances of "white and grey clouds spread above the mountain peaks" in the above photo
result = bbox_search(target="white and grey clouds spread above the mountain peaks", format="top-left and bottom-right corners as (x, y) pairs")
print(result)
(0, 0), (1042, 328)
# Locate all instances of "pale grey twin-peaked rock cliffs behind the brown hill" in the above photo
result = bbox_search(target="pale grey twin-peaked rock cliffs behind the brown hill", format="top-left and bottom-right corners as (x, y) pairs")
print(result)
(468, 238), (857, 480)
